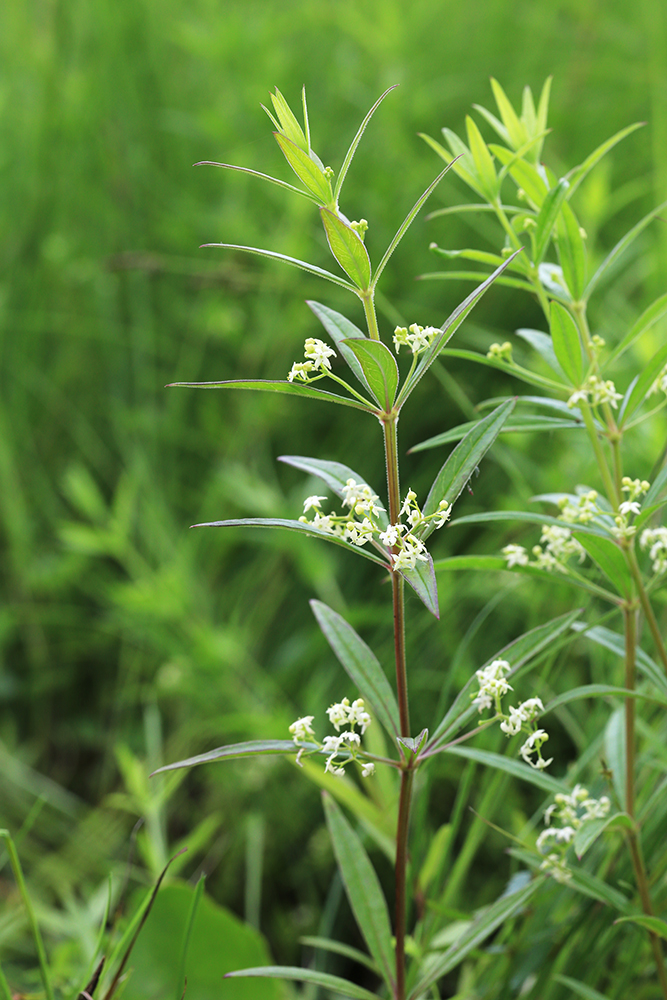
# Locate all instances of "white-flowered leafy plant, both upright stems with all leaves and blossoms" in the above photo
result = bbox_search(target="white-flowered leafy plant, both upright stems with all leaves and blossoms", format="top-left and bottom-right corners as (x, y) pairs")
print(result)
(157, 81), (667, 1000)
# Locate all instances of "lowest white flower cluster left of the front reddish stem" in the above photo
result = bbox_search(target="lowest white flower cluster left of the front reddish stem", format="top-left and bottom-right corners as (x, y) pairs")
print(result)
(289, 698), (375, 778)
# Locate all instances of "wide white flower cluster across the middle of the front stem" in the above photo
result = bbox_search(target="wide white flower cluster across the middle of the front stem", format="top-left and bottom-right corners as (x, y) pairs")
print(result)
(299, 479), (451, 570)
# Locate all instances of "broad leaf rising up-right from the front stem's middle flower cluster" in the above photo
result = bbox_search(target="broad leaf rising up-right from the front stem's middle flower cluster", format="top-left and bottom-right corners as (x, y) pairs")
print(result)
(421, 399), (516, 539)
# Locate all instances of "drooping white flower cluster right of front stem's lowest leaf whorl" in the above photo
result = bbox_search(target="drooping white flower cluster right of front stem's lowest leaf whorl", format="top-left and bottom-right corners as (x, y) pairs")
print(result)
(472, 660), (553, 771)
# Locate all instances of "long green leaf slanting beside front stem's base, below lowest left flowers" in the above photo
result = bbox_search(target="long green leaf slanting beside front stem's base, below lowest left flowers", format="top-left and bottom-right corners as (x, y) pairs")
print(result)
(322, 793), (395, 992)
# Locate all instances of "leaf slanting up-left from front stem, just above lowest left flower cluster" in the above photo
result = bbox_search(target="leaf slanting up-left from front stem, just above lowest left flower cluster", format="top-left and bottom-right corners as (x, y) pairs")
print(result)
(310, 601), (400, 736)
